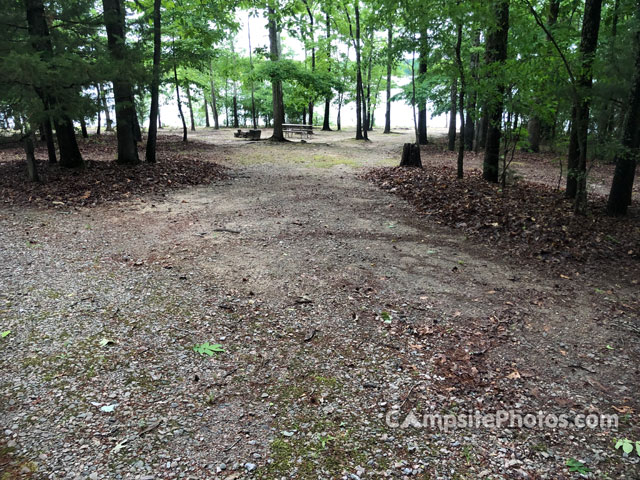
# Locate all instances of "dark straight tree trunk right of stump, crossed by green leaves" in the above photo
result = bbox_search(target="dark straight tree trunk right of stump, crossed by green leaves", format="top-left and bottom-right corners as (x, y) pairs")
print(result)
(482, 0), (509, 183)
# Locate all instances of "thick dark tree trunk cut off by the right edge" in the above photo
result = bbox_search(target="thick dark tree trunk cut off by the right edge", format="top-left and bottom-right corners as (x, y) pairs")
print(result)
(607, 1), (640, 215)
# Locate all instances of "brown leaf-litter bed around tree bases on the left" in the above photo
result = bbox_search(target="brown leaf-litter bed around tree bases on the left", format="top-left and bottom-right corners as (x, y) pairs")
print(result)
(0, 135), (225, 207)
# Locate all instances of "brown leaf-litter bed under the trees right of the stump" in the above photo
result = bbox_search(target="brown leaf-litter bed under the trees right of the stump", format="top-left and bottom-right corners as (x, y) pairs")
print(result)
(366, 166), (640, 263)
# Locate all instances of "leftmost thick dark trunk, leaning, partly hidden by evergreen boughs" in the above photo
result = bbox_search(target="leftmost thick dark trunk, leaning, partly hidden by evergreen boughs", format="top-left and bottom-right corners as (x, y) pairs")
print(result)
(24, 0), (84, 168)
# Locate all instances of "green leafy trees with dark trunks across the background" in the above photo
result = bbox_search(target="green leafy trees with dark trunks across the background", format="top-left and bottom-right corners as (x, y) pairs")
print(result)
(0, 0), (640, 215)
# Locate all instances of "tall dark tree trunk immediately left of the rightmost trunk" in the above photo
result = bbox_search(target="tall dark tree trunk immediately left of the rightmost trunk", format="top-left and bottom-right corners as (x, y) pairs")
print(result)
(574, 0), (602, 215)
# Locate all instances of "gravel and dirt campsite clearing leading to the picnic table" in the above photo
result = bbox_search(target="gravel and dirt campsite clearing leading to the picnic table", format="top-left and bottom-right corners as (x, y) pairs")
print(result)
(0, 130), (640, 480)
